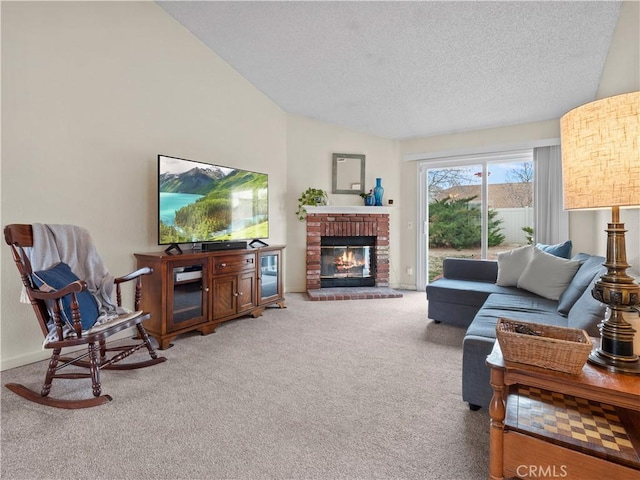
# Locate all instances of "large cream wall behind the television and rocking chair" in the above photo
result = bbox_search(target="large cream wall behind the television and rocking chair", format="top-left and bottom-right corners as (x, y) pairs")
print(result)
(0, 2), (290, 369)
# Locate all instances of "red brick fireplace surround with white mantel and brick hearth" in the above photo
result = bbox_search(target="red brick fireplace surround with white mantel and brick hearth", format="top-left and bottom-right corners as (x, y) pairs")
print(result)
(307, 207), (402, 300)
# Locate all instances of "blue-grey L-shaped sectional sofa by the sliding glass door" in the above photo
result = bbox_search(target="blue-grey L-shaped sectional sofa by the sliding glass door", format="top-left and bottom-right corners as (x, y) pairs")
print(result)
(426, 247), (606, 410)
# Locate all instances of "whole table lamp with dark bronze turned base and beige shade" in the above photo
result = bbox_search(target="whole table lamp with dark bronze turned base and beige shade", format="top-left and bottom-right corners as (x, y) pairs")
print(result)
(560, 92), (640, 375)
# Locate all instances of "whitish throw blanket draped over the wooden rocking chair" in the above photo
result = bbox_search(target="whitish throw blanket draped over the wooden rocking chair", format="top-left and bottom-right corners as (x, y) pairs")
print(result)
(25, 223), (128, 341)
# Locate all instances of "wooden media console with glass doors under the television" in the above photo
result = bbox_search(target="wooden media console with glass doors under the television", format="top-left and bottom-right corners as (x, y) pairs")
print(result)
(134, 245), (285, 349)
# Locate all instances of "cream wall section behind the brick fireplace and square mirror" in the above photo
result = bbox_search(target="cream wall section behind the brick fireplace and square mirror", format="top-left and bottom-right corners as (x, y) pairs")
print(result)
(286, 115), (400, 292)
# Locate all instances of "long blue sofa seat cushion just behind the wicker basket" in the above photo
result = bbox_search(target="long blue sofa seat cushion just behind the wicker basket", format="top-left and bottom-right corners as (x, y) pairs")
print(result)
(465, 294), (567, 338)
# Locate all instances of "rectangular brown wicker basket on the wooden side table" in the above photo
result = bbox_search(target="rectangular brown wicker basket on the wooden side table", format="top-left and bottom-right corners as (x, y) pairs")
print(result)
(496, 318), (593, 375)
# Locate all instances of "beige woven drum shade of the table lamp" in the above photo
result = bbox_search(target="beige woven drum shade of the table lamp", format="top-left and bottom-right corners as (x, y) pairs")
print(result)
(560, 92), (640, 210)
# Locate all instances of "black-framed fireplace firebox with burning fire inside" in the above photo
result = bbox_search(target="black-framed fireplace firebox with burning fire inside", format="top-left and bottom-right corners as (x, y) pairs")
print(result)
(320, 236), (376, 288)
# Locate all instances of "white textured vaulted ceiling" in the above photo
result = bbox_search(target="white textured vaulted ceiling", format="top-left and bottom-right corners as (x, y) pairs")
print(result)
(158, 1), (620, 138)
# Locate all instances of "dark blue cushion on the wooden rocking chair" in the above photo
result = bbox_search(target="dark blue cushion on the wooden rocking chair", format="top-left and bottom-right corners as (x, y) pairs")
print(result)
(32, 262), (99, 330)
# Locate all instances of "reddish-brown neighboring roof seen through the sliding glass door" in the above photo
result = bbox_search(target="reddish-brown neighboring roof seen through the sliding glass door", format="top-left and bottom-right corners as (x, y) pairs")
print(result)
(436, 182), (533, 208)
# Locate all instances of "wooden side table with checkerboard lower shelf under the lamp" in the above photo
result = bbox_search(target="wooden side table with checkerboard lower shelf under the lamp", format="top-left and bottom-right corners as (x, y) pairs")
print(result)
(487, 339), (640, 480)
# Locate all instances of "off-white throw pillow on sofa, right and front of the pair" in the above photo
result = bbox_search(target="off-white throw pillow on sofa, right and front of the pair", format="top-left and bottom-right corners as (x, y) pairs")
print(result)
(518, 248), (580, 300)
